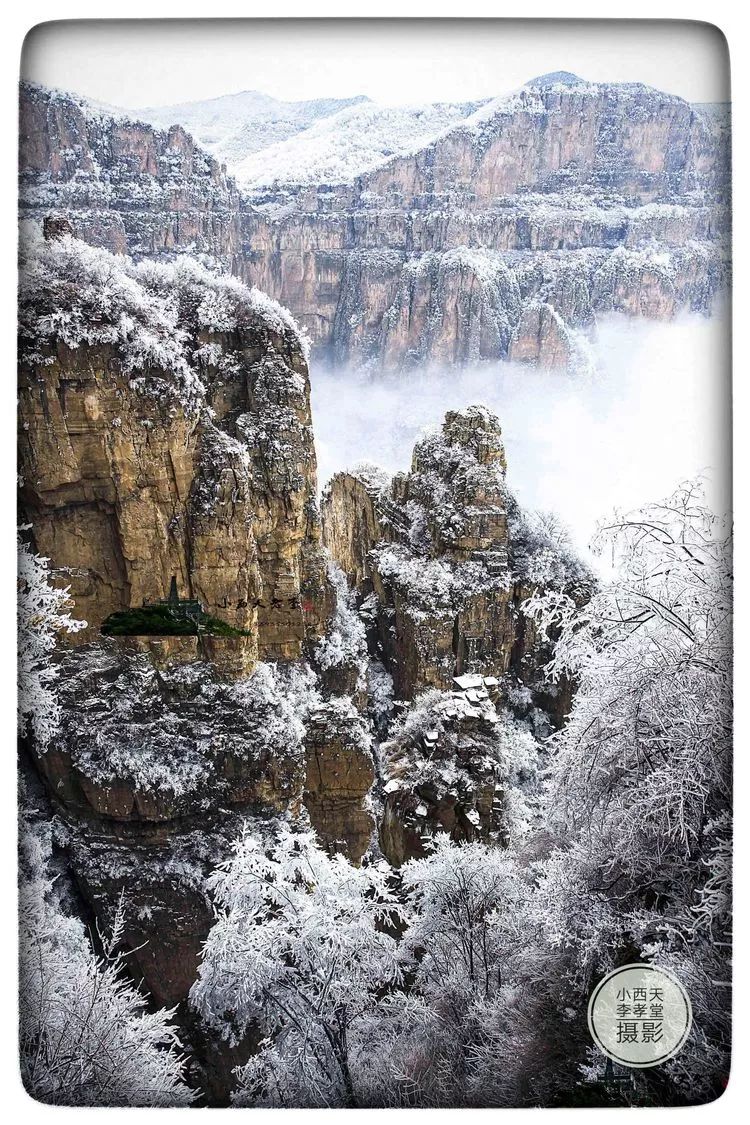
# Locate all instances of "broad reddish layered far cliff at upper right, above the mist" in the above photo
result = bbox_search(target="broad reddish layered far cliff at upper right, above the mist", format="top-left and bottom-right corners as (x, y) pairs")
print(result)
(241, 83), (728, 367)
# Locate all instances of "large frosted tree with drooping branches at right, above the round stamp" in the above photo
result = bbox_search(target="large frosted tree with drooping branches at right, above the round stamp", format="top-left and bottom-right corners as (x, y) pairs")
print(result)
(530, 486), (732, 898)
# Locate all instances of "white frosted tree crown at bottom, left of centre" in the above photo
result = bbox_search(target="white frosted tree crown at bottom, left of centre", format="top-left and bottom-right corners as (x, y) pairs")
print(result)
(190, 825), (401, 1061)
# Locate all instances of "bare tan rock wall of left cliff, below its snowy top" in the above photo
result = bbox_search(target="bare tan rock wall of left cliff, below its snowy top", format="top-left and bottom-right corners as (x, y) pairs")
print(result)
(19, 333), (332, 668)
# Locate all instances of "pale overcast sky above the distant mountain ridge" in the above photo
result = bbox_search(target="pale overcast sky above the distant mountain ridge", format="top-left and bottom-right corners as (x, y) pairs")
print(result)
(22, 19), (729, 109)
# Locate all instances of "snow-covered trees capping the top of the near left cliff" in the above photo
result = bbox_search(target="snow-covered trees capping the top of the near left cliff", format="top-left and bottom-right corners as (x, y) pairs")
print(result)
(19, 226), (307, 405)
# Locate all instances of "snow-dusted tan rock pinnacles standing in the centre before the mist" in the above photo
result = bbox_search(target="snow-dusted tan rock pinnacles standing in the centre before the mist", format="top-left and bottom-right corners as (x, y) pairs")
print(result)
(323, 407), (593, 699)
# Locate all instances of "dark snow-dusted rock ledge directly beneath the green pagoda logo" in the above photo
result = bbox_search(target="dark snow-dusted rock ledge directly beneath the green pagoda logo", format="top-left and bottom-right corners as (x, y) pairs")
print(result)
(38, 638), (305, 831)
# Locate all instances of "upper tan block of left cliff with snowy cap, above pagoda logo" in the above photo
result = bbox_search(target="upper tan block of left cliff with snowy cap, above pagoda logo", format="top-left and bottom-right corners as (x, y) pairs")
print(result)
(19, 235), (332, 673)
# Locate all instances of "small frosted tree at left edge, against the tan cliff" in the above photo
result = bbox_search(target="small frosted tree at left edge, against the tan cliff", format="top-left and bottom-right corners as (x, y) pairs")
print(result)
(18, 540), (85, 752)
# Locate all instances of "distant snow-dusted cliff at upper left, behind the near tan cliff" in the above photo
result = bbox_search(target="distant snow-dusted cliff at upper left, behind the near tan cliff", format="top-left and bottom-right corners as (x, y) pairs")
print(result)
(19, 83), (241, 268)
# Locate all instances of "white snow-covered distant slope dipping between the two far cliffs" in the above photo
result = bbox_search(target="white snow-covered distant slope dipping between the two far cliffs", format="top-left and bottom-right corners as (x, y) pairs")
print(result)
(133, 90), (368, 171)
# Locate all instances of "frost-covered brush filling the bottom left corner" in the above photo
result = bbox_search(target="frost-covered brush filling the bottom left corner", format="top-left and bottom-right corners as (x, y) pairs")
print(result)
(19, 801), (195, 1106)
